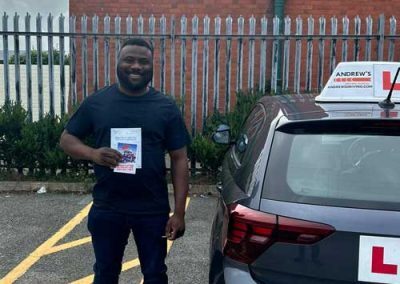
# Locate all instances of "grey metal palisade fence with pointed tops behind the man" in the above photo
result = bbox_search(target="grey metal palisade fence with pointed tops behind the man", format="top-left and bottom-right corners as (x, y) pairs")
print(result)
(0, 14), (399, 131)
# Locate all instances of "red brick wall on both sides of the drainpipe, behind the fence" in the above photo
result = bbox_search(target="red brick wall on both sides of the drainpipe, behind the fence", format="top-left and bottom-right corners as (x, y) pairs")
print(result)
(70, 0), (400, 130)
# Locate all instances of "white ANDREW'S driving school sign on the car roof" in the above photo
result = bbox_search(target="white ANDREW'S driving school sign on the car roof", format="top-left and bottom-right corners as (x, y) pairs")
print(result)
(315, 61), (400, 102)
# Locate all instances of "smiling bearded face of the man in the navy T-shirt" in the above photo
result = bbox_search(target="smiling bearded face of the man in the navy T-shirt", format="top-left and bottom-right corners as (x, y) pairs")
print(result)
(117, 45), (153, 93)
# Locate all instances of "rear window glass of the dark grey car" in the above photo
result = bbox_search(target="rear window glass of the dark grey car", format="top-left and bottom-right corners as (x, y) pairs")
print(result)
(263, 122), (400, 210)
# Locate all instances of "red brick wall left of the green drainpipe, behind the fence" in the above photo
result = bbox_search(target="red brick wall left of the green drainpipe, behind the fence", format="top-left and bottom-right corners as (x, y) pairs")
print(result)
(69, 0), (272, 128)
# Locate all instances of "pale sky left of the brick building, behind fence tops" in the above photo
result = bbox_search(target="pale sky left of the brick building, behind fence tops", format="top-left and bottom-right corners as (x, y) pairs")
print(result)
(0, 0), (69, 50)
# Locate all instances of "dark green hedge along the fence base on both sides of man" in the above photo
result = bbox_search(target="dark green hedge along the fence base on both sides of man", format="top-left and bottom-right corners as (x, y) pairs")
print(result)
(0, 91), (262, 180)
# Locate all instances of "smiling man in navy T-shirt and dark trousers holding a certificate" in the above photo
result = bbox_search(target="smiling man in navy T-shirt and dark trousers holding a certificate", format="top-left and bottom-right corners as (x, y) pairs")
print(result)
(60, 38), (189, 284)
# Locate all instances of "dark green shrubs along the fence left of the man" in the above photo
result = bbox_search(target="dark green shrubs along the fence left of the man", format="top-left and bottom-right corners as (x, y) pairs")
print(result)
(0, 101), (93, 180)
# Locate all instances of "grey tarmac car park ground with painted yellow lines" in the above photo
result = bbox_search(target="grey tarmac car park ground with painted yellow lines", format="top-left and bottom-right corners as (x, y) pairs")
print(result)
(0, 191), (217, 284)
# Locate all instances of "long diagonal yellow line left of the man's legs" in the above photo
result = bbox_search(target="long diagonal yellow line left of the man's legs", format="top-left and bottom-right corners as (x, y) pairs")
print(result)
(0, 203), (92, 284)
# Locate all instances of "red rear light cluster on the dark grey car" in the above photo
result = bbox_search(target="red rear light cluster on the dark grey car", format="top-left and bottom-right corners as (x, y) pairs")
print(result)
(224, 204), (335, 264)
